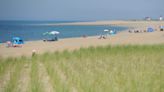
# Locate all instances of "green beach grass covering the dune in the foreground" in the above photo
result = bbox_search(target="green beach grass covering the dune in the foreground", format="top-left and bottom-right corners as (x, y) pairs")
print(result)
(0, 45), (164, 92)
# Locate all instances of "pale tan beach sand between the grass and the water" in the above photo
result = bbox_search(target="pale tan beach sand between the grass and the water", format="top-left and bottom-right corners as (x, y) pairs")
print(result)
(0, 21), (164, 57)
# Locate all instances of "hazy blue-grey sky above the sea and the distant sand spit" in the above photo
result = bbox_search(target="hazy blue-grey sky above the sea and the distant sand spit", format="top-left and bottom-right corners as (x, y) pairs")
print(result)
(0, 0), (164, 21)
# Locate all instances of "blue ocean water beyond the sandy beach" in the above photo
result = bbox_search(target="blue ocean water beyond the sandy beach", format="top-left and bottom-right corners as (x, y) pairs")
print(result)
(0, 21), (127, 42)
